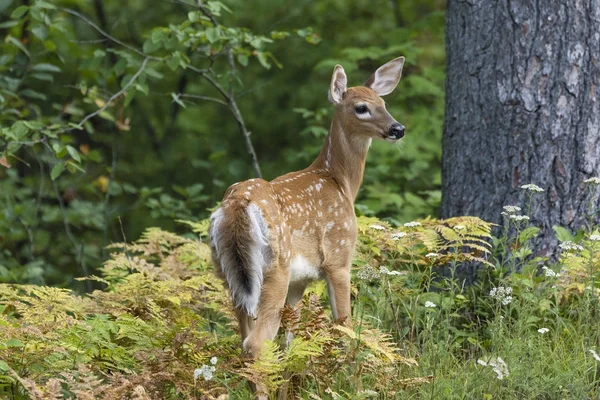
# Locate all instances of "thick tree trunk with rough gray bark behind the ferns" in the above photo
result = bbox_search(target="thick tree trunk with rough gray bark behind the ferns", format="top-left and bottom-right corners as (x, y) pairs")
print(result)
(441, 0), (600, 255)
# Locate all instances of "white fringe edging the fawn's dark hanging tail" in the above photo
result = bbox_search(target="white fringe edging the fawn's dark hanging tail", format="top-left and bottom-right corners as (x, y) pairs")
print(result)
(210, 203), (271, 317)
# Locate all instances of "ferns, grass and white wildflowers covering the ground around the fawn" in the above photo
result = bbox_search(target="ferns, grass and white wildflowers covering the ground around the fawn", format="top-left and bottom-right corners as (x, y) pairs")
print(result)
(0, 182), (600, 399)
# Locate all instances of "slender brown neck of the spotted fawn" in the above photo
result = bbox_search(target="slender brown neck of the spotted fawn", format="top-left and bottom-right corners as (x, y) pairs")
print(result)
(311, 113), (371, 203)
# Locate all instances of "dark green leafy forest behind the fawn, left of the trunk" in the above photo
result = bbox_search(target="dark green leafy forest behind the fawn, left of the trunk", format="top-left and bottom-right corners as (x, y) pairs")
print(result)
(0, 0), (445, 289)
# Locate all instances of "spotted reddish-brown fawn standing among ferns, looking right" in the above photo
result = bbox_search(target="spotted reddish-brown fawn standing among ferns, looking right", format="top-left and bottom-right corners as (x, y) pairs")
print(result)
(210, 57), (404, 356)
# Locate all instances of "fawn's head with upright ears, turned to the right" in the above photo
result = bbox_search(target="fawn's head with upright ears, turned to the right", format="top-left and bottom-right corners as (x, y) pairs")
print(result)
(329, 57), (404, 142)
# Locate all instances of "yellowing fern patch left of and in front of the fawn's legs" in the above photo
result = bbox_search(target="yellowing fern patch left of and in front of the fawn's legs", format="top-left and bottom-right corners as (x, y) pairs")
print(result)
(0, 217), (432, 398)
